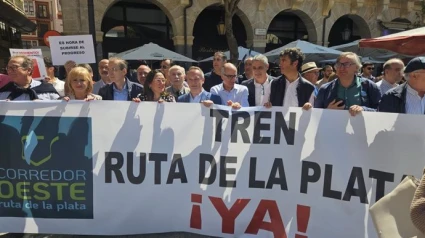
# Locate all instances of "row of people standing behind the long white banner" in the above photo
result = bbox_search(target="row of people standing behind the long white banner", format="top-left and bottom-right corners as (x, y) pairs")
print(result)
(0, 48), (425, 116)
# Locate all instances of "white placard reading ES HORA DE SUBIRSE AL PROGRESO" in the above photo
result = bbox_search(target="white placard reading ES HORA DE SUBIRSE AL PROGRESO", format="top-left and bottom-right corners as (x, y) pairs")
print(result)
(49, 35), (96, 65)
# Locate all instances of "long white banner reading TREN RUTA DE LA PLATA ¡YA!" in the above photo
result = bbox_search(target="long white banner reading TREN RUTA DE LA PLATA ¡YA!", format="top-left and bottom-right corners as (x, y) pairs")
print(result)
(0, 101), (425, 238)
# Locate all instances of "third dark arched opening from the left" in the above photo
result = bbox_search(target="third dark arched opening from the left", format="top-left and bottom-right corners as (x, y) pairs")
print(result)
(266, 10), (317, 52)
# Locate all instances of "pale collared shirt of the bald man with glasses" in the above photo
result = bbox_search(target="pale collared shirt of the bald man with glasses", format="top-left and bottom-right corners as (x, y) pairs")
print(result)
(210, 83), (249, 107)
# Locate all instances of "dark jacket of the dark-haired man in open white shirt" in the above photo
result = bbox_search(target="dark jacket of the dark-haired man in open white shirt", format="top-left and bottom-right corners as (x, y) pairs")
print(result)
(270, 75), (316, 107)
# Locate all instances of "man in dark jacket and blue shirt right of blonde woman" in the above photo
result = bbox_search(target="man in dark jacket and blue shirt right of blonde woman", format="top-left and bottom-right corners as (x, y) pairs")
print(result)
(99, 57), (143, 101)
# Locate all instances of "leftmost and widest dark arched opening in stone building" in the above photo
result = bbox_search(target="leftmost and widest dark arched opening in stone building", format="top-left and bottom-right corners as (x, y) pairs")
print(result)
(102, 0), (174, 58)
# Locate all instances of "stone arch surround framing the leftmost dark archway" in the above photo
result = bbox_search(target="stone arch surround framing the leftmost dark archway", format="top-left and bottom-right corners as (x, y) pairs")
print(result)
(94, 0), (177, 34)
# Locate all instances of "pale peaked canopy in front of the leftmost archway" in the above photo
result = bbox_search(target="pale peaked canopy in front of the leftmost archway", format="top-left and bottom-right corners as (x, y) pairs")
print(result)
(114, 43), (197, 62)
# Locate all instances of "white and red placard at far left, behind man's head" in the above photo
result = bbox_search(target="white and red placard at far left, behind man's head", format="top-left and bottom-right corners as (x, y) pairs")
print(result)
(9, 49), (47, 80)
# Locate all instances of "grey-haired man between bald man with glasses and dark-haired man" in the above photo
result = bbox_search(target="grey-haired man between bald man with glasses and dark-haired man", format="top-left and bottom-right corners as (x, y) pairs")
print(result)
(242, 54), (274, 107)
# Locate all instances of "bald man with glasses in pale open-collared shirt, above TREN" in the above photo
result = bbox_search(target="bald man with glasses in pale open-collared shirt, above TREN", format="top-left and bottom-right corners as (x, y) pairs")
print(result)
(210, 63), (249, 109)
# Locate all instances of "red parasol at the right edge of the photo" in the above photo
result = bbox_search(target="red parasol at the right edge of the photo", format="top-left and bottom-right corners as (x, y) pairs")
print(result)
(359, 27), (425, 56)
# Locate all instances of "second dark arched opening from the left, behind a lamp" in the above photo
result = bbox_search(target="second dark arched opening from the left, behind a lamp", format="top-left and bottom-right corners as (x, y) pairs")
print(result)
(192, 5), (247, 60)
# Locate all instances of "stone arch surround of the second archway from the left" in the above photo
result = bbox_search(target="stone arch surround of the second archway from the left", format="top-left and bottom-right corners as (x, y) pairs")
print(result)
(187, 0), (254, 41)
